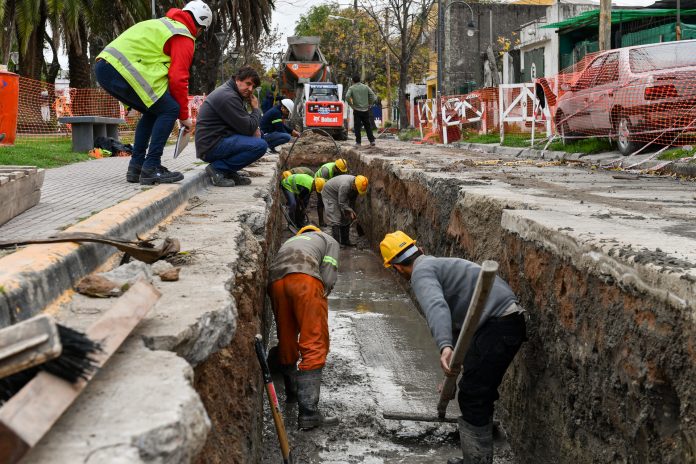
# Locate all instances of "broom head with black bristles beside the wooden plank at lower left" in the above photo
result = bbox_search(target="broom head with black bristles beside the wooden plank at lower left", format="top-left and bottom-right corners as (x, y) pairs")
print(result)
(0, 315), (101, 404)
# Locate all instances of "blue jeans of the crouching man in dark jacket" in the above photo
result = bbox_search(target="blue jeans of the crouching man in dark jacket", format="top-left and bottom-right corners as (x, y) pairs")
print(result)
(205, 134), (268, 173)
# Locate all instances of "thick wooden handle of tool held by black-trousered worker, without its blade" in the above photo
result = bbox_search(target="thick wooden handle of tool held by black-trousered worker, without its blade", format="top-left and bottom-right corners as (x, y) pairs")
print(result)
(437, 261), (498, 419)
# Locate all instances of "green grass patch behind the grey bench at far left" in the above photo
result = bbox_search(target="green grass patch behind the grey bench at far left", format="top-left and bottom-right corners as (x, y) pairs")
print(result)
(0, 139), (90, 168)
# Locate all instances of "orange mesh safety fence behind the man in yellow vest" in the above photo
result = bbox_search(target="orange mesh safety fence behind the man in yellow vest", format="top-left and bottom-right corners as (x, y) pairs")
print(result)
(17, 77), (205, 142)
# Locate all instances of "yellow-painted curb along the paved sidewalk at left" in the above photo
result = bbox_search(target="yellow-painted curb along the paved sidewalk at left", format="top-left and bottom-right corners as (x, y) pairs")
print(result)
(0, 167), (210, 327)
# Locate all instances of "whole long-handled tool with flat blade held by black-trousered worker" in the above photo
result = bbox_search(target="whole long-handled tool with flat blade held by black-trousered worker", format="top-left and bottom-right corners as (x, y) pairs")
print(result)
(382, 261), (498, 422)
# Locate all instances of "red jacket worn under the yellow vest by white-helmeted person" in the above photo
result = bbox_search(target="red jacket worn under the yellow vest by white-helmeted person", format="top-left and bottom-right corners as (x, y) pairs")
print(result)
(162, 8), (198, 119)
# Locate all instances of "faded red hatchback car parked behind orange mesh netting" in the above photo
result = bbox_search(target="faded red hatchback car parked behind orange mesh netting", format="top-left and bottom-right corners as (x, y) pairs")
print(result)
(554, 40), (696, 155)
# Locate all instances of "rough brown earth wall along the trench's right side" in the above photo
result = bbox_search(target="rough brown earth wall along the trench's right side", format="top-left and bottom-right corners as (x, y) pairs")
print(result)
(346, 151), (696, 463)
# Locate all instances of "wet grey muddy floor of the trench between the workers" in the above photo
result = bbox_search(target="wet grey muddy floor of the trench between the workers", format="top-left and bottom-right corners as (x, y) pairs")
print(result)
(262, 236), (516, 464)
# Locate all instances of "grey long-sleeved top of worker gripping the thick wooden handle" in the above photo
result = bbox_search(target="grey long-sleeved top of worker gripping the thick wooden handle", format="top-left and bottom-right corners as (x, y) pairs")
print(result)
(411, 255), (517, 351)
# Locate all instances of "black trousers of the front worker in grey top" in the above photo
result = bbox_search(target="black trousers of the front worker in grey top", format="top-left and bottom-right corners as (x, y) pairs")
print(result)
(457, 314), (527, 427)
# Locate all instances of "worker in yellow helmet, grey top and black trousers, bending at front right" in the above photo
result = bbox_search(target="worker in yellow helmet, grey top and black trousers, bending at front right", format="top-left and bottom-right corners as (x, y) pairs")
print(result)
(379, 230), (527, 464)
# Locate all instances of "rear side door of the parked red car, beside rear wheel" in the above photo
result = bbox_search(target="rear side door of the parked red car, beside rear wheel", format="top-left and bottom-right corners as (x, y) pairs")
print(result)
(588, 51), (620, 135)
